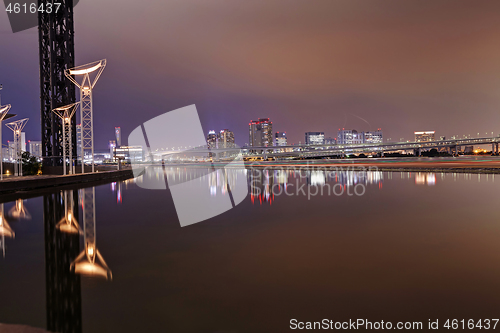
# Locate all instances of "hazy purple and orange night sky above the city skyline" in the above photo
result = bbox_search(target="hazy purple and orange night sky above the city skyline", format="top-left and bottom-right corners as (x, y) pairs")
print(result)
(0, 0), (500, 149)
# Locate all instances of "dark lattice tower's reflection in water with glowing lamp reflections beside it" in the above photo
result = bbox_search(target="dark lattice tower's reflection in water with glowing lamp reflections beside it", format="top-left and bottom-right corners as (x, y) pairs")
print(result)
(42, 188), (111, 333)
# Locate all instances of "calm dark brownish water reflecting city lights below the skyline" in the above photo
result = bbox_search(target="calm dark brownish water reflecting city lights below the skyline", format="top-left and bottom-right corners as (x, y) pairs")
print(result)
(0, 169), (500, 332)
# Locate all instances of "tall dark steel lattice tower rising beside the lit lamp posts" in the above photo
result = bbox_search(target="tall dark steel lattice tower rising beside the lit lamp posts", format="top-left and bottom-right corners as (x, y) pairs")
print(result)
(38, 0), (76, 166)
